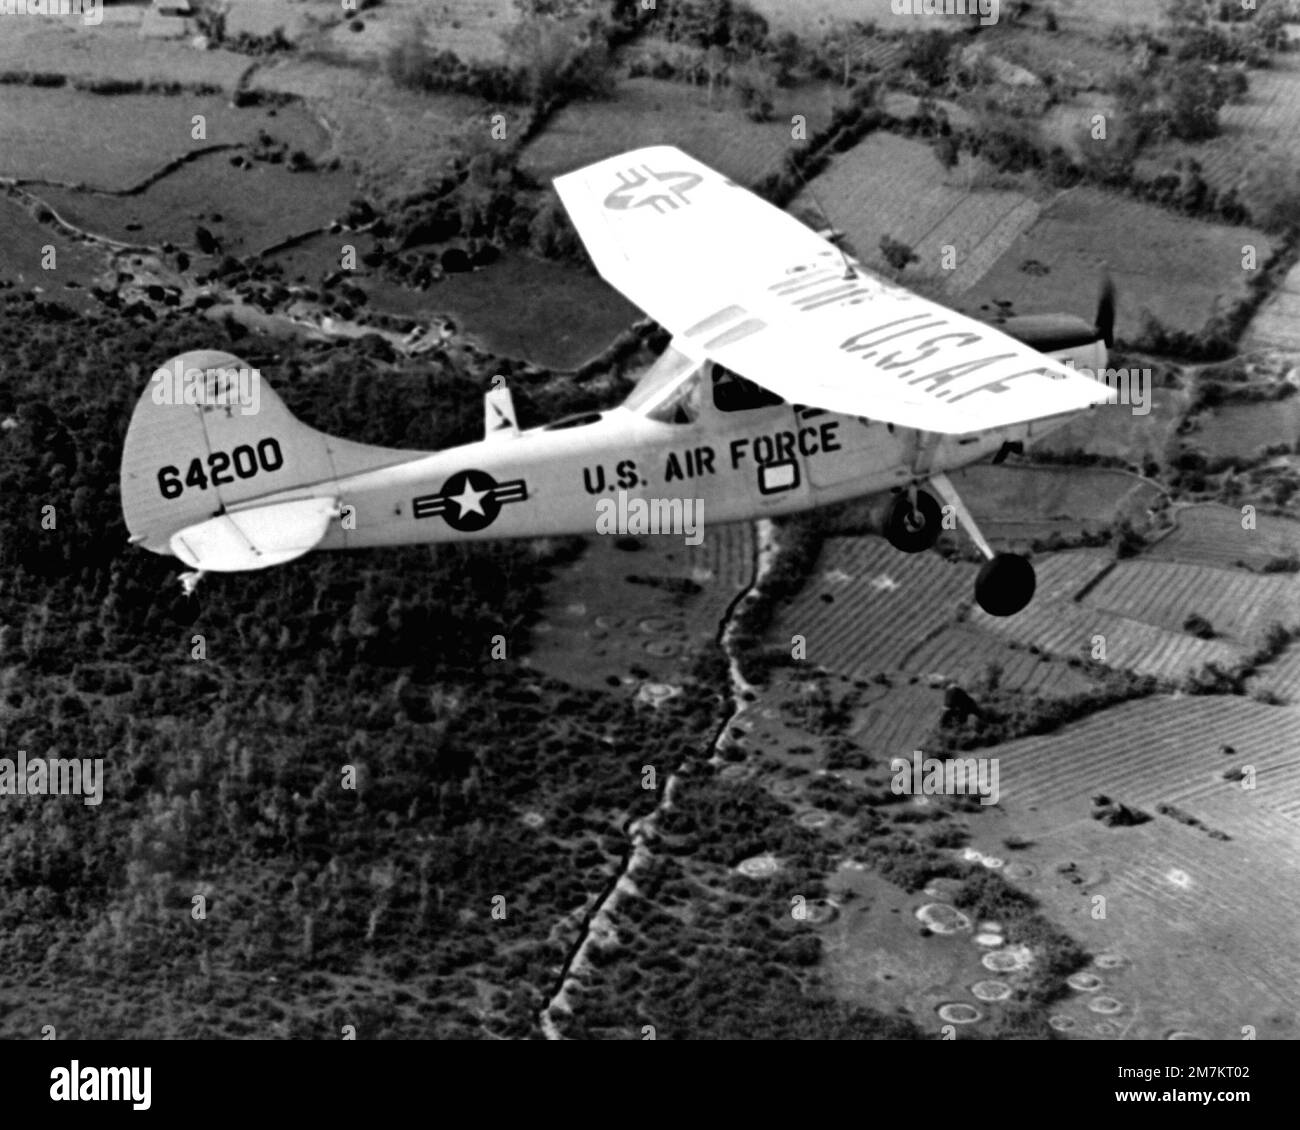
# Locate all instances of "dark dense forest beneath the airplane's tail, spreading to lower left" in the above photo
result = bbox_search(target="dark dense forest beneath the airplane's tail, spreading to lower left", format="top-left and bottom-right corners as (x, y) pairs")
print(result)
(0, 294), (935, 1038)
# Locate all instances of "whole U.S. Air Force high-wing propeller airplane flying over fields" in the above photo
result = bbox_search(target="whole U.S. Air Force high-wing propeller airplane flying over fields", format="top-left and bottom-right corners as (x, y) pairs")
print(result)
(121, 146), (1114, 616)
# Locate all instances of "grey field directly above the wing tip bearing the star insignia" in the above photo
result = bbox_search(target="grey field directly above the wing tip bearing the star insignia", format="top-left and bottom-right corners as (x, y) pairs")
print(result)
(520, 78), (837, 185)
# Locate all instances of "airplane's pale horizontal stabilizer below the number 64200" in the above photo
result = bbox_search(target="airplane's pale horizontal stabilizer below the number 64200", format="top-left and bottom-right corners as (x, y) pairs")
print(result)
(172, 498), (338, 572)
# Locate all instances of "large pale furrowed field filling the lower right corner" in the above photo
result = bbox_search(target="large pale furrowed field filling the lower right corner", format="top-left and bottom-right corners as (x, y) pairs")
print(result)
(975, 697), (1300, 1039)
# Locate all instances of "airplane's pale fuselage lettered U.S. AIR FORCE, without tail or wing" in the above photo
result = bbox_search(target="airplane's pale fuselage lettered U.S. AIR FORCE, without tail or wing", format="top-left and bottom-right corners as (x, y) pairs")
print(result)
(299, 387), (1075, 549)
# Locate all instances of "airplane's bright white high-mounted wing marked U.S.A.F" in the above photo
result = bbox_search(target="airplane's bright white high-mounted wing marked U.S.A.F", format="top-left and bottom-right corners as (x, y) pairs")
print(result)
(555, 146), (1112, 434)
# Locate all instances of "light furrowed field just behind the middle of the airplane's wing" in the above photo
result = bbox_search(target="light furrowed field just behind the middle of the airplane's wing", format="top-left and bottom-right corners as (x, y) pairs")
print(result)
(792, 133), (1040, 294)
